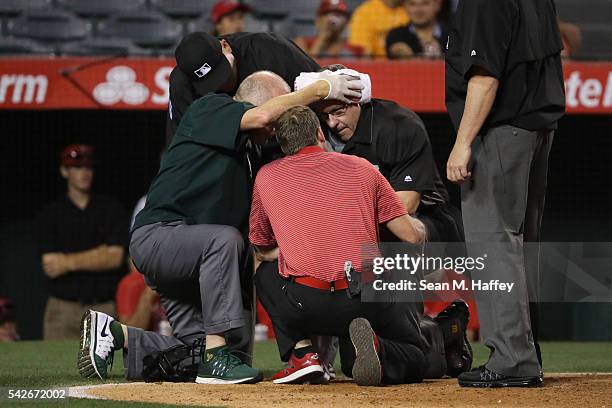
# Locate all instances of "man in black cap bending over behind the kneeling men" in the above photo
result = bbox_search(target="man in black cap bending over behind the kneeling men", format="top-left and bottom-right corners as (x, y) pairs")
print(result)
(166, 32), (320, 142)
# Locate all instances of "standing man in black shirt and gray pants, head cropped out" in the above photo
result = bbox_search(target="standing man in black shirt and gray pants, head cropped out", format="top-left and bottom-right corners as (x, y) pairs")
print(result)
(446, 0), (565, 387)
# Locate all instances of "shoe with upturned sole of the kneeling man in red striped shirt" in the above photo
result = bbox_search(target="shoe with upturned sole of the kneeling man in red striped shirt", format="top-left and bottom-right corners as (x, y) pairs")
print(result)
(349, 317), (382, 385)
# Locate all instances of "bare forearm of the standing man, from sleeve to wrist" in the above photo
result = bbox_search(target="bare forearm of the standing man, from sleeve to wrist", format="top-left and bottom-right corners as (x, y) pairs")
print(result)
(455, 74), (499, 146)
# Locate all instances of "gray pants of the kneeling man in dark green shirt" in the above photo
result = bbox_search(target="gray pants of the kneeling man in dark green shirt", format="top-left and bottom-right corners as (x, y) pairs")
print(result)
(124, 221), (252, 379)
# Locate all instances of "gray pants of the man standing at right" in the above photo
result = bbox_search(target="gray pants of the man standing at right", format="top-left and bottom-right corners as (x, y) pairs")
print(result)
(461, 126), (554, 376)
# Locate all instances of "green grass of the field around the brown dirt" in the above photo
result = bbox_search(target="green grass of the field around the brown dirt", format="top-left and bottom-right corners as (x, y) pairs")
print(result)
(0, 341), (612, 407)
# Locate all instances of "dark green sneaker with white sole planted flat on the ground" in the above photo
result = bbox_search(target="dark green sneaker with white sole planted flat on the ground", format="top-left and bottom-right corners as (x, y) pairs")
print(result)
(196, 347), (263, 384)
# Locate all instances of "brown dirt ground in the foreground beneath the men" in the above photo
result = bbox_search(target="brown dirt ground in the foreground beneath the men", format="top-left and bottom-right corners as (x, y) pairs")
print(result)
(82, 374), (612, 408)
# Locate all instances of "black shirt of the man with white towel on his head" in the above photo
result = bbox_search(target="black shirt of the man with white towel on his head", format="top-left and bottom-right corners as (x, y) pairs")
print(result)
(342, 99), (448, 212)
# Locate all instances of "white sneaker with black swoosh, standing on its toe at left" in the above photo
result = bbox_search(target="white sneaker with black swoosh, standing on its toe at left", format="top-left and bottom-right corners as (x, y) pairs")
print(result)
(77, 310), (115, 380)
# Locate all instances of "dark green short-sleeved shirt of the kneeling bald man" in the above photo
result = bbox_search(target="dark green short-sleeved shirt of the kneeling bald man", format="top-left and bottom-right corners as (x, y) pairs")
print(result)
(132, 94), (252, 232)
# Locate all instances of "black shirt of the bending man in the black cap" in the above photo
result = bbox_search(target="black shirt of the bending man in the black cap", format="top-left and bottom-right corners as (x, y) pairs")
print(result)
(166, 33), (321, 143)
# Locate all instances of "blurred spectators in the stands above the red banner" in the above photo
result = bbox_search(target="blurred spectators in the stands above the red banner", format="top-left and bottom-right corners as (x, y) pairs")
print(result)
(210, 0), (581, 59)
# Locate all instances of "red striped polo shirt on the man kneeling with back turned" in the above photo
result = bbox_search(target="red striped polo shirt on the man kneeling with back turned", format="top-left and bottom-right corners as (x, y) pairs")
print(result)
(249, 146), (406, 282)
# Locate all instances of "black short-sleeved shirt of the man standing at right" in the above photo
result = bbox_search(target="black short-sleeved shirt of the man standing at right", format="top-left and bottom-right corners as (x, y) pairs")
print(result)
(446, 0), (565, 130)
